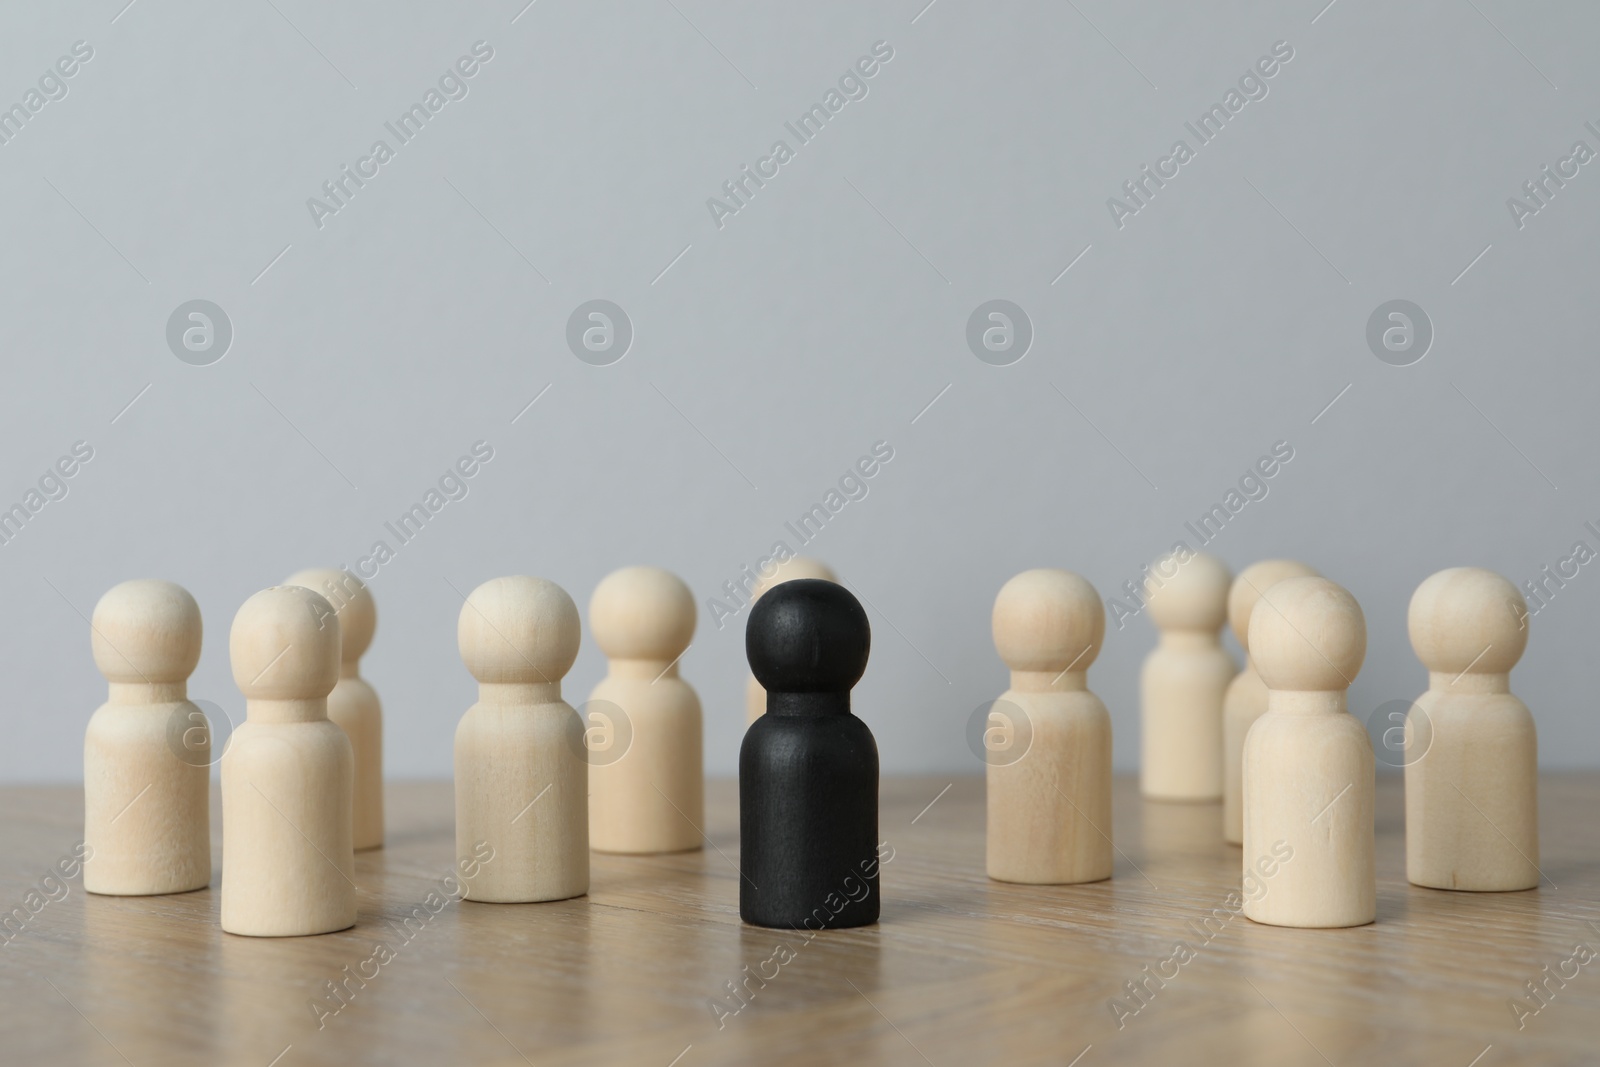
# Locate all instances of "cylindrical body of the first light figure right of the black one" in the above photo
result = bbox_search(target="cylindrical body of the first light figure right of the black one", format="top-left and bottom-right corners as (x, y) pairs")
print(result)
(986, 684), (1112, 885)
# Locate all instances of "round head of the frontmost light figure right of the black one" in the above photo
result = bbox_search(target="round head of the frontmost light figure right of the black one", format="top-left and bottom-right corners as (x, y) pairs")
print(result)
(1246, 577), (1366, 691)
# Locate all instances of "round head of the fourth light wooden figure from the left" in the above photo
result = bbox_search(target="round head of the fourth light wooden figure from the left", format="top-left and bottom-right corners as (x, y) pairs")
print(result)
(456, 574), (582, 685)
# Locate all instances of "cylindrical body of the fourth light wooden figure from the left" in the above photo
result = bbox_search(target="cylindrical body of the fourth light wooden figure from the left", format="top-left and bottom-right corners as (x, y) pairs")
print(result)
(456, 683), (589, 904)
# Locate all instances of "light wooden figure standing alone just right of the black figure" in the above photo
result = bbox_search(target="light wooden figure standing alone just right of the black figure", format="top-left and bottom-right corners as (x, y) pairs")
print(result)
(986, 569), (1112, 885)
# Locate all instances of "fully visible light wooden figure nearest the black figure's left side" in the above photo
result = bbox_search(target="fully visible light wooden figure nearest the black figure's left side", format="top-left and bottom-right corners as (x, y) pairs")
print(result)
(584, 566), (706, 853)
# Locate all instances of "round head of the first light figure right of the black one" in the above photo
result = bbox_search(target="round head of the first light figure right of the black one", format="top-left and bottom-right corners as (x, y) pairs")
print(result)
(990, 568), (1106, 673)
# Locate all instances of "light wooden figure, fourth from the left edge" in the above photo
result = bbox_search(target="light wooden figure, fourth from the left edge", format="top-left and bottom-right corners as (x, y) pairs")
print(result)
(456, 577), (589, 904)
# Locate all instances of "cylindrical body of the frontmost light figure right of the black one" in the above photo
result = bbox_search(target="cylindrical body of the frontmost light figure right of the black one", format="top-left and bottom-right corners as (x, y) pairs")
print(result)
(1243, 691), (1378, 926)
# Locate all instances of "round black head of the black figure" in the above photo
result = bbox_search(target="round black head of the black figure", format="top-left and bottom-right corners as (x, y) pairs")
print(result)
(744, 577), (872, 693)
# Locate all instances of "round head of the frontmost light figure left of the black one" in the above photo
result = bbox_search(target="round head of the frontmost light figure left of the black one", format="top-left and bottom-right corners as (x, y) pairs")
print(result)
(227, 585), (341, 701)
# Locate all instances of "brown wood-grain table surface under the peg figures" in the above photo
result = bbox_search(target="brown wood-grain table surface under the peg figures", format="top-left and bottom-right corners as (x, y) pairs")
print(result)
(0, 773), (1600, 1067)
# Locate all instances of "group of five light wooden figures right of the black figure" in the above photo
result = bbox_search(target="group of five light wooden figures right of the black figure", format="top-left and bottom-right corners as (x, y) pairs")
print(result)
(987, 550), (1539, 928)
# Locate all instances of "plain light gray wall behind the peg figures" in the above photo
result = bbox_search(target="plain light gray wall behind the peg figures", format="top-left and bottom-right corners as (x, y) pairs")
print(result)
(0, 0), (1600, 781)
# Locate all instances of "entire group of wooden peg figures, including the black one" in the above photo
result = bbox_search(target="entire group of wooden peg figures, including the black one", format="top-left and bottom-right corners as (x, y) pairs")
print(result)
(83, 552), (1539, 936)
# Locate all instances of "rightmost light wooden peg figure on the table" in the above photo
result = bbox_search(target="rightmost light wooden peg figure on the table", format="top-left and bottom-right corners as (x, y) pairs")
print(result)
(1405, 566), (1539, 891)
